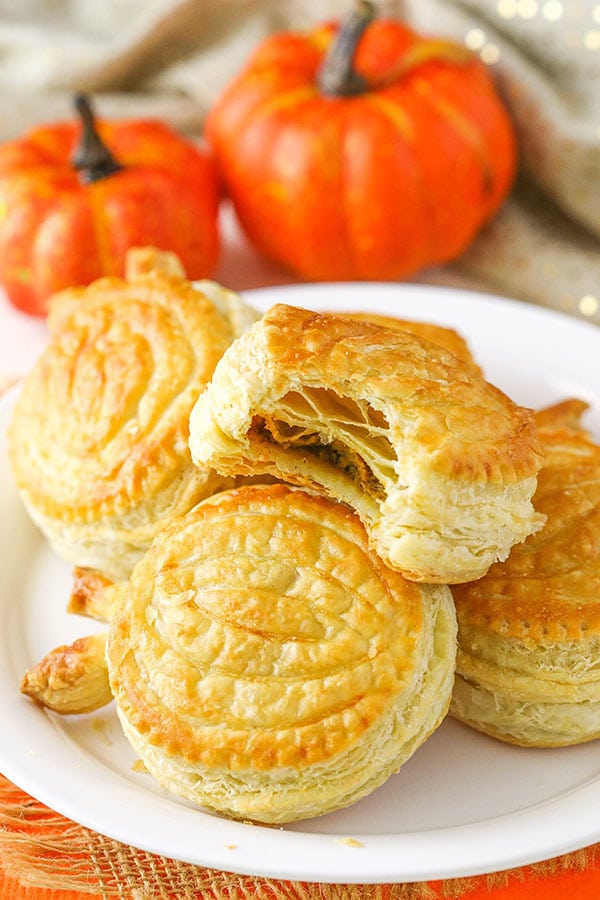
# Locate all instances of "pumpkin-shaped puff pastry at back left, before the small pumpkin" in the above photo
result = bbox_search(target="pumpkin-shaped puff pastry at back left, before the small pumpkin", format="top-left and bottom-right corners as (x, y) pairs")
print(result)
(9, 248), (258, 580)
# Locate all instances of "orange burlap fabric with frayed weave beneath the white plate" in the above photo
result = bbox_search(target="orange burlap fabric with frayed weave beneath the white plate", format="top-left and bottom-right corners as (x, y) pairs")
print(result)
(0, 776), (600, 900)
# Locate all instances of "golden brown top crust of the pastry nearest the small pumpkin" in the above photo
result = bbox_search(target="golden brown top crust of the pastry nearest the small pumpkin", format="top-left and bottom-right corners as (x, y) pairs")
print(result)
(18, 268), (230, 521)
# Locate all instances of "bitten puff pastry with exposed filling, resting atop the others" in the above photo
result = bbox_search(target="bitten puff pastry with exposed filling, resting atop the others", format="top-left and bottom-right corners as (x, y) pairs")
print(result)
(190, 304), (542, 583)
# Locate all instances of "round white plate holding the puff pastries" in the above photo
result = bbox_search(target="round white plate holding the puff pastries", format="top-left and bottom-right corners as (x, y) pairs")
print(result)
(0, 284), (600, 883)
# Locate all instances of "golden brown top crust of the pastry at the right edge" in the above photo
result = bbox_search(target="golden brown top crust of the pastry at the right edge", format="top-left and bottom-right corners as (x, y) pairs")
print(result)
(453, 408), (600, 642)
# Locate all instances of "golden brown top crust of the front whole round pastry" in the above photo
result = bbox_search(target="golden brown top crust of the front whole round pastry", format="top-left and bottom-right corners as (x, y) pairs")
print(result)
(110, 485), (422, 768)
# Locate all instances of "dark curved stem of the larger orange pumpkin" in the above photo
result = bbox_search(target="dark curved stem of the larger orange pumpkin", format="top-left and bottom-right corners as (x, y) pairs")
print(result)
(317, 0), (375, 97)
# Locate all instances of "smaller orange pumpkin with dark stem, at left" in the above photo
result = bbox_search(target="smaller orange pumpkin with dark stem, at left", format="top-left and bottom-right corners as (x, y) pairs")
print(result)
(0, 96), (220, 315)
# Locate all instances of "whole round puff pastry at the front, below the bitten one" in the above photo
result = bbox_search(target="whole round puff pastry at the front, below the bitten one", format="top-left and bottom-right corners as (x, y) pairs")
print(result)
(107, 484), (456, 823)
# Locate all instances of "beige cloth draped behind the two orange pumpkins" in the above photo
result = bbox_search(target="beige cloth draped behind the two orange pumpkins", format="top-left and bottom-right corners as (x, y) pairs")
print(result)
(0, 0), (600, 322)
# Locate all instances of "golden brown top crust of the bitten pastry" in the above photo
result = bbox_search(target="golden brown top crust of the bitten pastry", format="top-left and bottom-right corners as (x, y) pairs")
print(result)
(252, 305), (541, 474)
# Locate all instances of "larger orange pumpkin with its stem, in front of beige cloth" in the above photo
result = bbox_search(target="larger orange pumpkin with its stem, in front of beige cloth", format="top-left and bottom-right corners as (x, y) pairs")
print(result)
(206, 2), (516, 280)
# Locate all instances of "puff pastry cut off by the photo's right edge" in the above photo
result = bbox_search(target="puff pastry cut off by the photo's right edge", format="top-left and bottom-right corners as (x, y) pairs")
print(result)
(451, 401), (600, 747)
